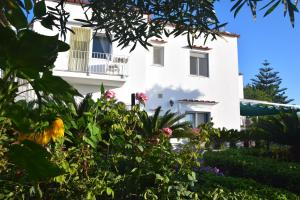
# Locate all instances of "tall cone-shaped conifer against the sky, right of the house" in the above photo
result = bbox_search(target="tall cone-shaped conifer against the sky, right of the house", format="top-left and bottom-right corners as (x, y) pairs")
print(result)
(247, 60), (293, 103)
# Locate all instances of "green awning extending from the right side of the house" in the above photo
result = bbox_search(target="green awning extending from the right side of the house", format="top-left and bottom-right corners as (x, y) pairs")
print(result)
(240, 102), (297, 116)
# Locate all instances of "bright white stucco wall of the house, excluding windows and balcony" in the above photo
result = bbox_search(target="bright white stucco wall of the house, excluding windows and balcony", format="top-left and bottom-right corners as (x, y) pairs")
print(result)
(34, 2), (241, 129)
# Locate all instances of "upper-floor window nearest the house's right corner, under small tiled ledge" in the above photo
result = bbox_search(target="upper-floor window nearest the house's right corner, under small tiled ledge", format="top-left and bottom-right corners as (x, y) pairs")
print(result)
(190, 52), (209, 77)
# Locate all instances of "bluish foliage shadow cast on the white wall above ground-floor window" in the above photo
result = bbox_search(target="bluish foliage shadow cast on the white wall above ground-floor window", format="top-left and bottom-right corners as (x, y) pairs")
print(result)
(146, 85), (204, 111)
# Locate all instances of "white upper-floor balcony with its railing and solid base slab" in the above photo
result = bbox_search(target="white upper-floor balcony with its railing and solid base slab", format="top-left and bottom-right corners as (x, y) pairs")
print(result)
(53, 50), (128, 87)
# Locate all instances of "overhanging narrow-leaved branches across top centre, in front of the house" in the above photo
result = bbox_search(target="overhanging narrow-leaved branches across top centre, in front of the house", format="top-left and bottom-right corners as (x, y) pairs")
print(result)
(78, 0), (225, 50)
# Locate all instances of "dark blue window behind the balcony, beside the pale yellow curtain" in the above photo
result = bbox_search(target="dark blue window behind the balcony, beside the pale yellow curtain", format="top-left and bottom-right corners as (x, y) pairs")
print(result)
(92, 35), (112, 58)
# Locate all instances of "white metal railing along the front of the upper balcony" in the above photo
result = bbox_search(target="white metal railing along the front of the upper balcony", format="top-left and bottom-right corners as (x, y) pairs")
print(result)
(68, 50), (128, 76)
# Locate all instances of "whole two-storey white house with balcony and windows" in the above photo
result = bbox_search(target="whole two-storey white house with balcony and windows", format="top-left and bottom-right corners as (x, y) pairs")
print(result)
(34, 0), (242, 129)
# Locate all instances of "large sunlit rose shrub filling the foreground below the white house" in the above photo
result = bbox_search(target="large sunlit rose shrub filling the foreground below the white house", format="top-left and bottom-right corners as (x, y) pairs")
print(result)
(0, 90), (200, 199)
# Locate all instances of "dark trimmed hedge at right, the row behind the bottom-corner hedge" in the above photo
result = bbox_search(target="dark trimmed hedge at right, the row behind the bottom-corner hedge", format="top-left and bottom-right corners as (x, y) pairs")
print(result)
(204, 150), (300, 194)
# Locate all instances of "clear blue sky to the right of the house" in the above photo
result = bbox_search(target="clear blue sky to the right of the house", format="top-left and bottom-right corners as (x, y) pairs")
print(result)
(215, 0), (300, 105)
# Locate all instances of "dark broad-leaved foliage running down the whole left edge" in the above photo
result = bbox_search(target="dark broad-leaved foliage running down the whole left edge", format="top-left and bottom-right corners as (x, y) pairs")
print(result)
(0, 0), (79, 193)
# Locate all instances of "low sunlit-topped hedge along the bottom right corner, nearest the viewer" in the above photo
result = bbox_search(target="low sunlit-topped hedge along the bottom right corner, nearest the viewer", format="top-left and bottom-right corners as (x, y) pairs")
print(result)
(196, 173), (300, 200)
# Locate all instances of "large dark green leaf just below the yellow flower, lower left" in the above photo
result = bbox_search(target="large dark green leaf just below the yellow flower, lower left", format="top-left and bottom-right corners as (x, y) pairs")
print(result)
(8, 141), (64, 181)
